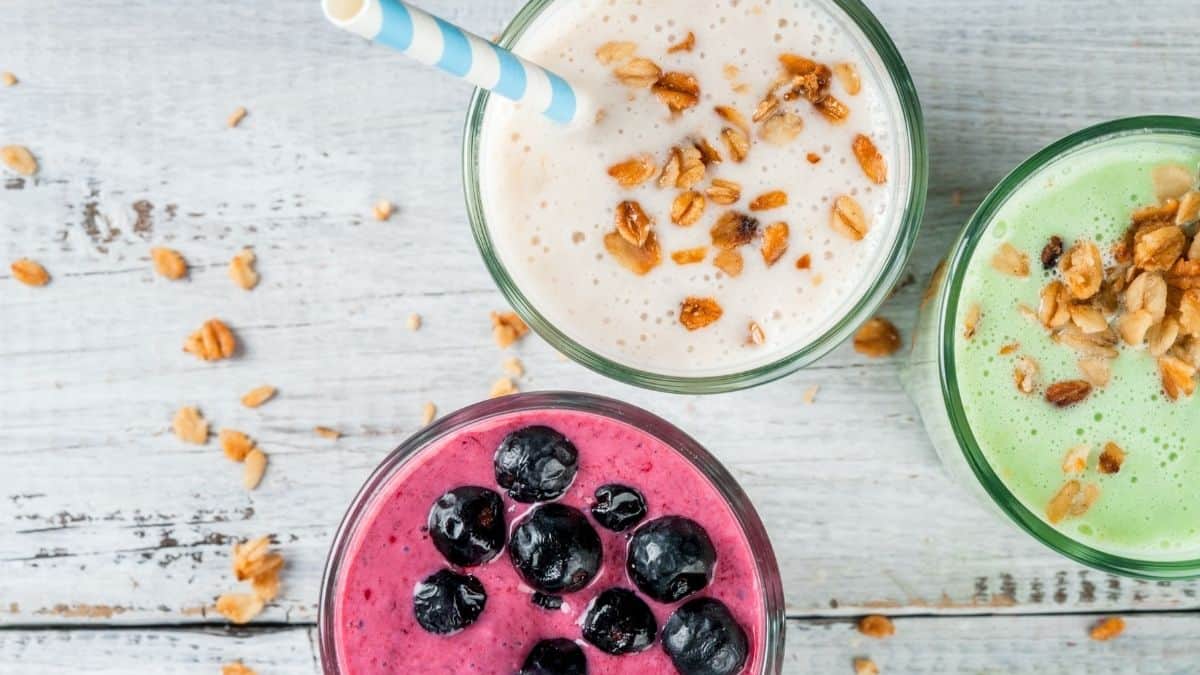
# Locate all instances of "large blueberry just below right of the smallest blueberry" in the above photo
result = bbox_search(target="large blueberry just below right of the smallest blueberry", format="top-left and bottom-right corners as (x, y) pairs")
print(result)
(626, 515), (716, 603)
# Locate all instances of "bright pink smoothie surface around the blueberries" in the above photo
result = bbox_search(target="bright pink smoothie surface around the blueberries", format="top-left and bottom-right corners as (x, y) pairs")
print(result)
(334, 410), (766, 675)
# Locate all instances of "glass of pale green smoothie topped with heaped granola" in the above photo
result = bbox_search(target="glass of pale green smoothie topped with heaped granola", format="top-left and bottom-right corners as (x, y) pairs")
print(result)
(905, 117), (1200, 579)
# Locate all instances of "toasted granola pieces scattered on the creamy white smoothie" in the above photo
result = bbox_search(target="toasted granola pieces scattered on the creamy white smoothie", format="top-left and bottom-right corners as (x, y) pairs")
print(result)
(595, 32), (888, 336)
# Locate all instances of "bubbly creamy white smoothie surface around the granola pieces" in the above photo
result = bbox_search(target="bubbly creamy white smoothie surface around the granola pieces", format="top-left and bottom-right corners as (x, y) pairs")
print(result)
(480, 0), (910, 376)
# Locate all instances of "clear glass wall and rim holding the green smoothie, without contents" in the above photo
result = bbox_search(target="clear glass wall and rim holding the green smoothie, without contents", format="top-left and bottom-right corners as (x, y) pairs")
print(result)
(902, 117), (1200, 579)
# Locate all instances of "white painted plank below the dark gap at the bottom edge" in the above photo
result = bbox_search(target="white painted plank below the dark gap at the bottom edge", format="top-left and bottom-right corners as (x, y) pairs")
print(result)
(0, 614), (1200, 675)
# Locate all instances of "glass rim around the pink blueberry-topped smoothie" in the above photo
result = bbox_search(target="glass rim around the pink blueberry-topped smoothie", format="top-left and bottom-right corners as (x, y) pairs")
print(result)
(317, 392), (787, 675)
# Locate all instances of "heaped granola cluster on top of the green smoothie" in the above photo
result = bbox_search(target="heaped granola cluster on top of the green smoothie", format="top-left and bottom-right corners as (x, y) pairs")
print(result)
(992, 165), (1200, 407)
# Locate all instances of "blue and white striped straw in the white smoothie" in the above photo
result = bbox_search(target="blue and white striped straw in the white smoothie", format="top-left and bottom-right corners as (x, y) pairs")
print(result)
(322, 0), (578, 124)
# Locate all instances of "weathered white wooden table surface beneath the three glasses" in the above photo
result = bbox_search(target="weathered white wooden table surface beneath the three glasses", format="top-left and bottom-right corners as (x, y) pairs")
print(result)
(0, 0), (1200, 675)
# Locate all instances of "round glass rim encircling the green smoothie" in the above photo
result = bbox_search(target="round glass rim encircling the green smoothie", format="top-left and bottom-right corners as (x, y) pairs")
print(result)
(936, 115), (1200, 580)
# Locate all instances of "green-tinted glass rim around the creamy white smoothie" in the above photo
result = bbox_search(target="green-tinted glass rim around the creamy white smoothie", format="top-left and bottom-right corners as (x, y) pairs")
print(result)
(462, 0), (929, 394)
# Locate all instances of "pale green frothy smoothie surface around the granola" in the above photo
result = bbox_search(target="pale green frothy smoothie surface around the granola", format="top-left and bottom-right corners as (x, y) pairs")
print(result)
(954, 133), (1200, 561)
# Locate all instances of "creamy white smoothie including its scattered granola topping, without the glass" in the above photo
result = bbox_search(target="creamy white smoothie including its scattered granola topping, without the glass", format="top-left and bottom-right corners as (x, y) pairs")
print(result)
(479, 0), (912, 377)
